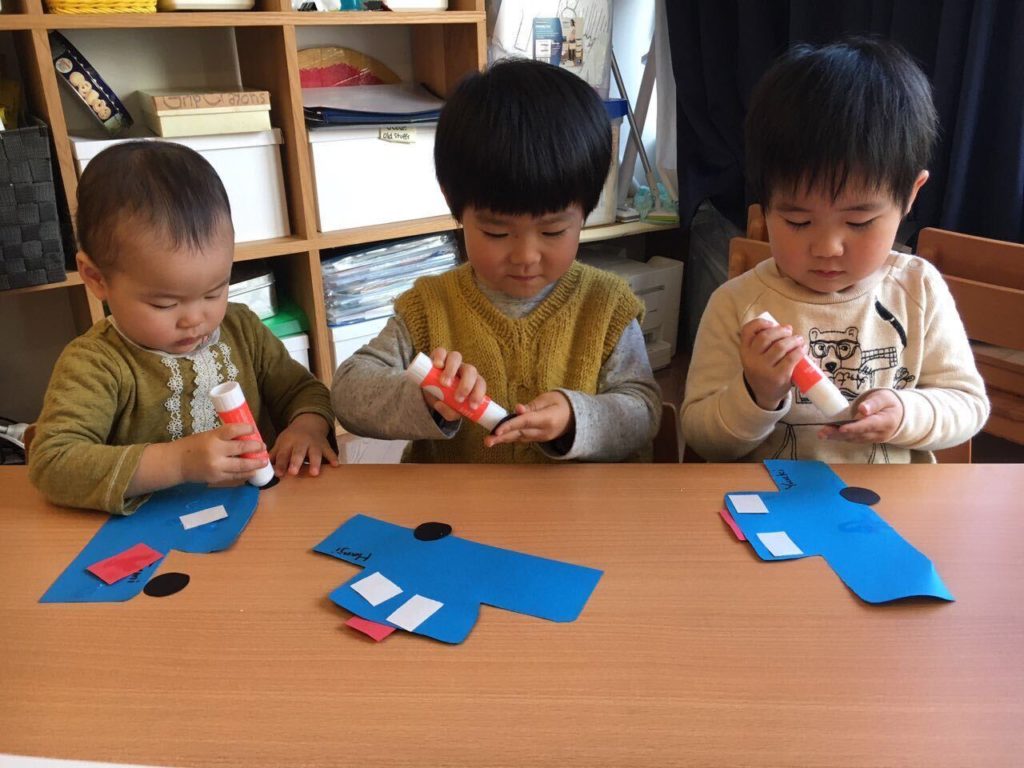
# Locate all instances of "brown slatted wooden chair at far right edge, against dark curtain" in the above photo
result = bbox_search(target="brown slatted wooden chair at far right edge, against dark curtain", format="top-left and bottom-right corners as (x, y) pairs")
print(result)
(918, 227), (1024, 444)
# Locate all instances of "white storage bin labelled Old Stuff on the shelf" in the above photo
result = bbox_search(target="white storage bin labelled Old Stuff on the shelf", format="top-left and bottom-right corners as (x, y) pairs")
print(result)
(309, 123), (450, 232)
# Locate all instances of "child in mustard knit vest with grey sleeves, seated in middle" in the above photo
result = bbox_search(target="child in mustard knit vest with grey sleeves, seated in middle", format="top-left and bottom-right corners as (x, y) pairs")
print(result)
(333, 59), (662, 463)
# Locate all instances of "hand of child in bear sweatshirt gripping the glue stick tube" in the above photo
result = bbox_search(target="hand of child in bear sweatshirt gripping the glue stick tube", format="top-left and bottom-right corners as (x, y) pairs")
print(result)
(739, 317), (804, 411)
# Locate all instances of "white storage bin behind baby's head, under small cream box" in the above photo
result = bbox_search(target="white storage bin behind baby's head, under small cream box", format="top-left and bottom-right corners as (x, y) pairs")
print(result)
(71, 128), (291, 243)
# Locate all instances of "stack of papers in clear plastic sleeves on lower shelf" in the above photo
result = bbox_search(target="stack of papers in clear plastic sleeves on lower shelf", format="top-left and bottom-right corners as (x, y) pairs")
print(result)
(322, 232), (458, 326)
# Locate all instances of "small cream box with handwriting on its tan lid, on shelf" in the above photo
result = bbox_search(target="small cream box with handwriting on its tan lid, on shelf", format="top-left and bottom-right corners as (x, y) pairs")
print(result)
(139, 89), (270, 138)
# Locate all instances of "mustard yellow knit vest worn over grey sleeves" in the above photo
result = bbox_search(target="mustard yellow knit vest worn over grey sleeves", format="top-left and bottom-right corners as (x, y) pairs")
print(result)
(395, 262), (643, 464)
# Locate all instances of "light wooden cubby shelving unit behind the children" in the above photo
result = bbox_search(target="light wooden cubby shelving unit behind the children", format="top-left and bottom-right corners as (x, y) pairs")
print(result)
(0, 0), (486, 381)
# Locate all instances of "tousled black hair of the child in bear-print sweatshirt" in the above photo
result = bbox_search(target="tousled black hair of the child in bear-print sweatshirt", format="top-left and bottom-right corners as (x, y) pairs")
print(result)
(745, 38), (938, 210)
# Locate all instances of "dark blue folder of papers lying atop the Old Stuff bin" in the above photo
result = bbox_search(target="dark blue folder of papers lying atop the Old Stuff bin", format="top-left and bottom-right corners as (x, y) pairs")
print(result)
(302, 83), (444, 126)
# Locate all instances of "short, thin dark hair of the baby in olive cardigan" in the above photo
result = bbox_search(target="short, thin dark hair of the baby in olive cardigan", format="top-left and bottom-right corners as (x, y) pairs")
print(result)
(76, 141), (231, 268)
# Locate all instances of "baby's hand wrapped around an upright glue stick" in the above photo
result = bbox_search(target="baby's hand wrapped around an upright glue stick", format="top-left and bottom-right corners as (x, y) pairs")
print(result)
(177, 424), (266, 484)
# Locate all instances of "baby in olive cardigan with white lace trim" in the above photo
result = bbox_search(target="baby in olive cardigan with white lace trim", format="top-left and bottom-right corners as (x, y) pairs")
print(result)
(29, 141), (337, 514)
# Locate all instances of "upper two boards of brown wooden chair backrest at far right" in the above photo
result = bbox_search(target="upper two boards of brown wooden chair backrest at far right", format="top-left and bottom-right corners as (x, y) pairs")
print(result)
(918, 227), (1024, 350)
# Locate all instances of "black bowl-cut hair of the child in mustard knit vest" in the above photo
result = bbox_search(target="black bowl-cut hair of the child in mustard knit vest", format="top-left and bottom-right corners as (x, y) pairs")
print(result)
(434, 58), (611, 221)
